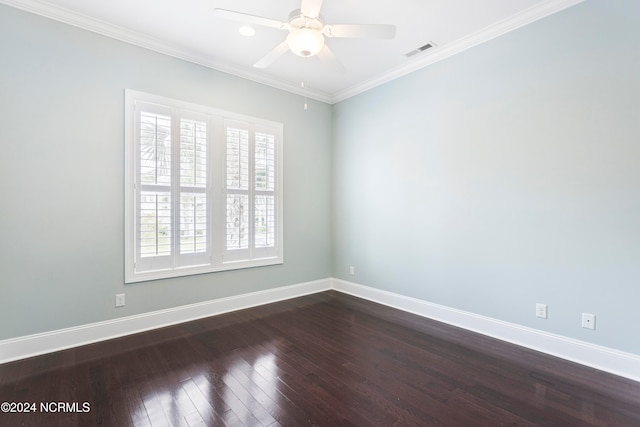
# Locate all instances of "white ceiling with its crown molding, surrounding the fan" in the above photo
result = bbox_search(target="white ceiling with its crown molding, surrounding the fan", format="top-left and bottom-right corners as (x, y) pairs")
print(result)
(0, 0), (582, 103)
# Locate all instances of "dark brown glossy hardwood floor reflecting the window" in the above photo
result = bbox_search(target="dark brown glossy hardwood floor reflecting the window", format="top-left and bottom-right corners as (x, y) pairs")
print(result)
(0, 291), (640, 426)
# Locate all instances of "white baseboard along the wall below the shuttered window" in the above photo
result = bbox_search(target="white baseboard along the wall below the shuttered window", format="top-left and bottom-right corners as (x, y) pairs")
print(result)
(0, 279), (332, 363)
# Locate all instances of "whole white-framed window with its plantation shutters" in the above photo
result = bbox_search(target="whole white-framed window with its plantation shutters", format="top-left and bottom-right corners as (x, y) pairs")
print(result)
(125, 90), (282, 283)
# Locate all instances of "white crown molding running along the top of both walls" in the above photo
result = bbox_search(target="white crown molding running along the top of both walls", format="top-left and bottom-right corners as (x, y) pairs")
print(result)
(0, 0), (584, 104)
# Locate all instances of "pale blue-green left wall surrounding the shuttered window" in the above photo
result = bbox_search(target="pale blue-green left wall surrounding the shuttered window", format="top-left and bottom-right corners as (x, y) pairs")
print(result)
(0, 5), (331, 339)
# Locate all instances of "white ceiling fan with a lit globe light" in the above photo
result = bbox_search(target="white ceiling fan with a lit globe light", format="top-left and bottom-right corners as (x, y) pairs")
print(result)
(213, 0), (396, 68)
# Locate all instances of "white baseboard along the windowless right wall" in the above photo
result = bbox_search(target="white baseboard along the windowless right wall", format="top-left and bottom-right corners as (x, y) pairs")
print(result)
(332, 279), (640, 381)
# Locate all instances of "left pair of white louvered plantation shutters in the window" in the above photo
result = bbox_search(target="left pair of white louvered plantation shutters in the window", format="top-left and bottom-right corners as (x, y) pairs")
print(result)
(129, 101), (211, 272)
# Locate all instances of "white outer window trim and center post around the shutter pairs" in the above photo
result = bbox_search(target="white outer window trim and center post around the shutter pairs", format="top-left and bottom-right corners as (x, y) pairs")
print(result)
(124, 89), (284, 283)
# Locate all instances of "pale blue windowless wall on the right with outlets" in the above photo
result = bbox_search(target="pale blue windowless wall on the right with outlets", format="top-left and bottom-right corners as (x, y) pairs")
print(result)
(332, 0), (640, 354)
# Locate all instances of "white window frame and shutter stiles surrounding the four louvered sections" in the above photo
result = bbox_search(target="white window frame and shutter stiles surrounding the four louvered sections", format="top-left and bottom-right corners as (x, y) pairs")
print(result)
(124, 89), (284, 283)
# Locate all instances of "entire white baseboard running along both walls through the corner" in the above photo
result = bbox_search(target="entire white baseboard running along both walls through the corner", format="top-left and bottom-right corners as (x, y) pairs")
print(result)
(0, 278), (640, 382)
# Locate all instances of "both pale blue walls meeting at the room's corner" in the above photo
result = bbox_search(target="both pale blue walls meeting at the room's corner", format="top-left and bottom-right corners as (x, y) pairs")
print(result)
(0, 0), (640, 354)
